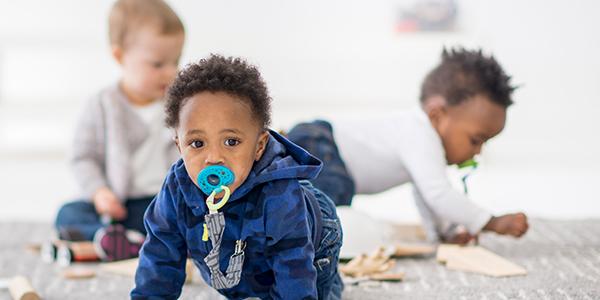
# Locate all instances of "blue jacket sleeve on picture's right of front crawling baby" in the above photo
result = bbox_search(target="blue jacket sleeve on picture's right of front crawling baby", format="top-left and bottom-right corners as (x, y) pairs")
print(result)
(265, 181), (317, 299)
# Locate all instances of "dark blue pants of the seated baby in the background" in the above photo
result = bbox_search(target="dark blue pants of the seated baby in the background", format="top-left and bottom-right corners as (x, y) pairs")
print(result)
(55, 196), (154, 241)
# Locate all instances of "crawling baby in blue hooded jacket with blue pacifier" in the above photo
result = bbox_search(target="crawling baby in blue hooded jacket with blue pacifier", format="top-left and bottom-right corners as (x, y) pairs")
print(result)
(131, 55), (343, 299)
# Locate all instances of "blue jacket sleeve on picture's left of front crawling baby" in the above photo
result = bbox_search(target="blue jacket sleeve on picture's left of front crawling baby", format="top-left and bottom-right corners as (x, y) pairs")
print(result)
(131, 183), (187, 299)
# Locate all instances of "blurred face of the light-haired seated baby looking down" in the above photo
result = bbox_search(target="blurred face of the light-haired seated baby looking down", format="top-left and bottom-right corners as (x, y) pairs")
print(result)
(120, 28), (184, 102)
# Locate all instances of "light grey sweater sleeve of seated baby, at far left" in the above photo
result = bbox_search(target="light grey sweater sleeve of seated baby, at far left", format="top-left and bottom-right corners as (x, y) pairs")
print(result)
(70, 95), (108, 201)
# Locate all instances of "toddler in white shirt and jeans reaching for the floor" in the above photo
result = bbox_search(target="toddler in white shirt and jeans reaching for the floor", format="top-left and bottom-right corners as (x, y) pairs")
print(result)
(288, 48), (528, 244)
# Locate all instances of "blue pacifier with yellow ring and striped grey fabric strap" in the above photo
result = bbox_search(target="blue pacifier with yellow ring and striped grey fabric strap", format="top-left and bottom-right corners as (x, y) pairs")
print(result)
(198, 166), (246, 290)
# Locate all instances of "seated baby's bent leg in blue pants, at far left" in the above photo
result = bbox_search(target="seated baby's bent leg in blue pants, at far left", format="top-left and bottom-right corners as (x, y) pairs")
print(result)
(55, 201), (102, 241)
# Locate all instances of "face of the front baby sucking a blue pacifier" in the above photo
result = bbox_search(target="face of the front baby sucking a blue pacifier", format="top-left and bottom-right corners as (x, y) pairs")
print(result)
(176, 92), (268, 193)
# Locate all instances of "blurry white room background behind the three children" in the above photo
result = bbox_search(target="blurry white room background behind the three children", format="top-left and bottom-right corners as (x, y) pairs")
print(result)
(0, 0), (600, 223)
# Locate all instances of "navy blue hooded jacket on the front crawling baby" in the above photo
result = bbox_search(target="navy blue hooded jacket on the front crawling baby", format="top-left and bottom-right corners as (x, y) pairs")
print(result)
(131, 131), (321, 299)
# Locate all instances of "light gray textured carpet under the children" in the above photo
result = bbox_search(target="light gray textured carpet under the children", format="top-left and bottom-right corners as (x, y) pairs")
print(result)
(0, 220), (600, 299)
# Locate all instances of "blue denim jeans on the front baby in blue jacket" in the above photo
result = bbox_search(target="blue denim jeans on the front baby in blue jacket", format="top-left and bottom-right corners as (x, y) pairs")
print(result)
(314, 183), (344, 300)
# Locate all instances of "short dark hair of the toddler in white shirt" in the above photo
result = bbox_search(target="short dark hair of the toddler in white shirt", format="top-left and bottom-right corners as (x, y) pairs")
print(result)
(420, 48), (516, 108)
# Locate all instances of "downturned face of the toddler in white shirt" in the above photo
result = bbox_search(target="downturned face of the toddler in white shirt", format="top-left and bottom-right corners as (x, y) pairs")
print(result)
(437, 95), (506, 164)
